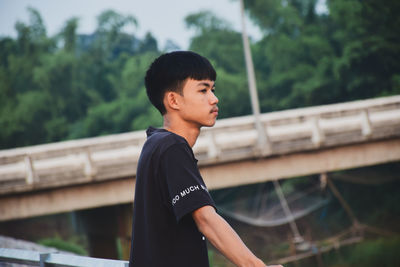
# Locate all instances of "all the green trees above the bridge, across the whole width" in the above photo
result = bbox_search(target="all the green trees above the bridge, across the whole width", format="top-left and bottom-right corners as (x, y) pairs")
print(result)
(0, 0), (400, 148)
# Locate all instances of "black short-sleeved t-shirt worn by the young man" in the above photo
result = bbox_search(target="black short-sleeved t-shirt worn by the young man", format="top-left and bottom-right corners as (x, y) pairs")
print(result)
(129, 127), (215, 267)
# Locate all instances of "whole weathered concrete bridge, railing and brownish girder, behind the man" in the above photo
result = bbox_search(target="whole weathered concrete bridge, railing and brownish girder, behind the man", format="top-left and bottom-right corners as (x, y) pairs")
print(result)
(0, 96), (400, 221)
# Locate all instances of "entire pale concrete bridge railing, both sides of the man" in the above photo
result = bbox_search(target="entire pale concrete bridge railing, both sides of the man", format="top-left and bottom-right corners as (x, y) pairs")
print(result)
(0, 96), (400, 194)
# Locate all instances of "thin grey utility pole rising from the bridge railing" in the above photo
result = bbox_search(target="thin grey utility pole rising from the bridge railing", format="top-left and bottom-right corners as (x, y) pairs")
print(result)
(239, 0), (270, 155)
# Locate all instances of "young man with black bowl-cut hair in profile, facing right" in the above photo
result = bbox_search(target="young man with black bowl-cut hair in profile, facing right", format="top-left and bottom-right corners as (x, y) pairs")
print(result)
(129, 51), (282, 267)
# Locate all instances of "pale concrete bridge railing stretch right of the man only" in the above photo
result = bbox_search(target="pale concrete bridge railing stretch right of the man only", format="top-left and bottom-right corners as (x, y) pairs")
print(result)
(194, 96), (400, 163)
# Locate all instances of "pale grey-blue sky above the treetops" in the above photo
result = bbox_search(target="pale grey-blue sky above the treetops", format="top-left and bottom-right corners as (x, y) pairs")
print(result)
(0, 0), (261, 49)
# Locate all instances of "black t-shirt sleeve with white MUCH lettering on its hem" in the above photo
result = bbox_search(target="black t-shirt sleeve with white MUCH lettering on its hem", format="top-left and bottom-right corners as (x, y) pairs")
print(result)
(161, 144), (215, 221)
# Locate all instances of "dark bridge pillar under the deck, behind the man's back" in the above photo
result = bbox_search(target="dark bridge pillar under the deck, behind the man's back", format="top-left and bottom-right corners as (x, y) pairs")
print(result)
(77, 204), (132, 260)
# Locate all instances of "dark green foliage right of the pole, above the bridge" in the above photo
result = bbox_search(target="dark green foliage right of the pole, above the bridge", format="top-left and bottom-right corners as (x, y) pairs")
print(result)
(245, 0), (400, 111)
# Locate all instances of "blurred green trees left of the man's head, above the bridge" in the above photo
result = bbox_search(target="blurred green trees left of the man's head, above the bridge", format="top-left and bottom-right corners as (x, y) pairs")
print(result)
(0, 8), (161, 148)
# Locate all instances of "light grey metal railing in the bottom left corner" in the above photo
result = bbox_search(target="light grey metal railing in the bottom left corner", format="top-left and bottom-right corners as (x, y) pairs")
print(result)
(0, 248), (129, 267)
